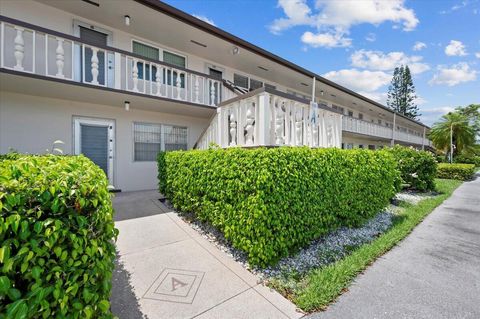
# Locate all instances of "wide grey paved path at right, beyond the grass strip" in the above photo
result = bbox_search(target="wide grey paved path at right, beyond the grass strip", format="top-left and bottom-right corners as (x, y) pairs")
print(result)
(310, 177), (480, 319)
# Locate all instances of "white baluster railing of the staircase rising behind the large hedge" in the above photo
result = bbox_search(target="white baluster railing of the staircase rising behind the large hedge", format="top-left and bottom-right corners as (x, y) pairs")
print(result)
(196, 88), (342, 149)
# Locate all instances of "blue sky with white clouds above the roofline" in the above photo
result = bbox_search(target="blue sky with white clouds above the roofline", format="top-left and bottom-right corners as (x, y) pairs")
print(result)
(167, 0), (480, 124)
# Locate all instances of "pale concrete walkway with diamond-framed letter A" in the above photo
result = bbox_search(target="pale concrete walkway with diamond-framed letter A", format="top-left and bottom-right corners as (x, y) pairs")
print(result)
(111, 191), (303, 319)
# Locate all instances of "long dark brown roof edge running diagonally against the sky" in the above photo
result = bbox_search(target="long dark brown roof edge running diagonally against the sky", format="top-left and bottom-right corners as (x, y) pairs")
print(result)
(134, 0), (430, 129)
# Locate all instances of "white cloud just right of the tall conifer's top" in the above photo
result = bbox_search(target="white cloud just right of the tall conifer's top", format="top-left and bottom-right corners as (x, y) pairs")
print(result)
(428, 62), (477, 86)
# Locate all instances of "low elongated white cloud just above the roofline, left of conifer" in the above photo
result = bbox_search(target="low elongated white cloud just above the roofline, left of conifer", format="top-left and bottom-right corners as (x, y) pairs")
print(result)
(323, 69), (391, 93)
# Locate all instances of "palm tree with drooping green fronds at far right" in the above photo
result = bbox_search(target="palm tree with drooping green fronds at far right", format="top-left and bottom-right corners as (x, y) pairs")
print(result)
(429, 112), (475, 161)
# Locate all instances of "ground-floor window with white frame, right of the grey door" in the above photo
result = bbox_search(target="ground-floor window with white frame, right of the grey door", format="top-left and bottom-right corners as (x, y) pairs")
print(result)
(133, 122), (188, 162)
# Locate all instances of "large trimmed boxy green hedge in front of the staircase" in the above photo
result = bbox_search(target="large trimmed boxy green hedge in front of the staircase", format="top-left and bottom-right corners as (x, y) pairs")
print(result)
(159, 147), (398, 266)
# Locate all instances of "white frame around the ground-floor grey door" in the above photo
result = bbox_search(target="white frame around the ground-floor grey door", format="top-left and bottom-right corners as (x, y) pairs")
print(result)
(73, 116), (116, 185)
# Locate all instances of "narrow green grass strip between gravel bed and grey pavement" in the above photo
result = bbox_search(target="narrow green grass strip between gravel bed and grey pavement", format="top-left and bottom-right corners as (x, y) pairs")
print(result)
(270, 179), (462, 312)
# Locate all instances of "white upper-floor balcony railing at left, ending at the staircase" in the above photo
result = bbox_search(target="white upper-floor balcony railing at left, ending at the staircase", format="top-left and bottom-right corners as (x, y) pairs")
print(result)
(0, 16), (225, 106)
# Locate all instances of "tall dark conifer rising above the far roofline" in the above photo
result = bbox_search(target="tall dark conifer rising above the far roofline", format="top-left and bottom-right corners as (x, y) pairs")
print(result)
(387, 65), (421, 120)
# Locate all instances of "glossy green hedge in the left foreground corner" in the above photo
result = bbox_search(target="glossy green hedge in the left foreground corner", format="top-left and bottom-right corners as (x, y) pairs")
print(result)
(0, 155), (118, 318)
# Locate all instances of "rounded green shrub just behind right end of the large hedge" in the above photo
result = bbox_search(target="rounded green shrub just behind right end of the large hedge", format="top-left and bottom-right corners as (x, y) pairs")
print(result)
(386, 145), (437, 191)
